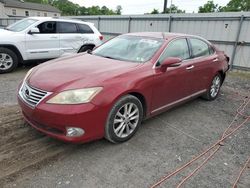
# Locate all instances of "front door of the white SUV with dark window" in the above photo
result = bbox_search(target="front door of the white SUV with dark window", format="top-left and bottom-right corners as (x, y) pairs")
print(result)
(25, 21), (60, 59)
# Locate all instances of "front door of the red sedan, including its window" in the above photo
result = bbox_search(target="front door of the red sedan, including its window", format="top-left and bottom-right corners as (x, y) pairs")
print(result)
(152, 38), (193, 113)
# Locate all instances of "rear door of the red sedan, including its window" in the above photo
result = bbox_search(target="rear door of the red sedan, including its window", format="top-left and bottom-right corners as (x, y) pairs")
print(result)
(186, 38), (218, 94)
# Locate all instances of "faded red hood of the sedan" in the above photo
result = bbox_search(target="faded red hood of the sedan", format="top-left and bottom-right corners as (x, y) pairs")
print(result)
(28, 54), (142, 92)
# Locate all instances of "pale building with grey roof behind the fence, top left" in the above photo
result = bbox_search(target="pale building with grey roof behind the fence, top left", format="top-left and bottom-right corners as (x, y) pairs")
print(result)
(0, 0), (61, 17)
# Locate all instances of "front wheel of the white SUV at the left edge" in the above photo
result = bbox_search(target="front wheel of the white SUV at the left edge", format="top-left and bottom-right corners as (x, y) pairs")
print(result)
(0, 48), (18, 73)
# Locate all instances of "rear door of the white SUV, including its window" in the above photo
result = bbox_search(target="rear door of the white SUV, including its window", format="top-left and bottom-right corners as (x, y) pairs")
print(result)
(58, 22), (83, 55)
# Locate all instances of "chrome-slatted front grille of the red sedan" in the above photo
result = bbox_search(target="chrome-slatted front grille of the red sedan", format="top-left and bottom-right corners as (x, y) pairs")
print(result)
(19, 82), (49, 107)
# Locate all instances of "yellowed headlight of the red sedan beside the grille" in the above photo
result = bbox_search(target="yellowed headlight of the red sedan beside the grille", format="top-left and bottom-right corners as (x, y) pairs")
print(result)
(47, 87), (102, 104)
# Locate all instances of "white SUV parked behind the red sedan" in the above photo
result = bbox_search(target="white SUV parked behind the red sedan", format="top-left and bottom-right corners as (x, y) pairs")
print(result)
(0, 17), (103, 73)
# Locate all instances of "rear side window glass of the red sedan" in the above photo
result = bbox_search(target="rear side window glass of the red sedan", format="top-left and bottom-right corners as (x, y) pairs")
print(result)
(190, 38), (210, 57)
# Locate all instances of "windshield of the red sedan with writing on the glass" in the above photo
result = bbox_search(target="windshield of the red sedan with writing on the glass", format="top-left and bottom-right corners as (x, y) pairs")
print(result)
(92, 36), (163, 63)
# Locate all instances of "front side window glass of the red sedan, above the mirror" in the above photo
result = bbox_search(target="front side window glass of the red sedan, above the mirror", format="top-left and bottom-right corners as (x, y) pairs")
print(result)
(159, 39), (190, 64)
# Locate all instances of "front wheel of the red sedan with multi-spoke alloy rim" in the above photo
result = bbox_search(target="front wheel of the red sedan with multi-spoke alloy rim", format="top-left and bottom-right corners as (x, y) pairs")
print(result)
(105, 95), (143, 143)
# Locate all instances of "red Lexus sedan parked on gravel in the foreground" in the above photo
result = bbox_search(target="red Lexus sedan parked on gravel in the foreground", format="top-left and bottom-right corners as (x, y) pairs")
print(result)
(18, 33), (229, 143)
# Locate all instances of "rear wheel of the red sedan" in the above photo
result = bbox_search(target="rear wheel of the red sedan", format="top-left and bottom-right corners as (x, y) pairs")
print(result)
(202, 74), (222, 101)
